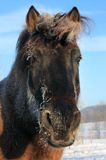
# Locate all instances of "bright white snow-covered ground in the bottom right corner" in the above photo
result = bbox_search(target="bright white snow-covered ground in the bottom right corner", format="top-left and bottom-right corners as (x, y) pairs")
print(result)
(62, 139), (106, 160)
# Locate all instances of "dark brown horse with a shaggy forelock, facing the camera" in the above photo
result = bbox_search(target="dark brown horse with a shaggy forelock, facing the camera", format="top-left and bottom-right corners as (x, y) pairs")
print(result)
(0, 6), (84, 160)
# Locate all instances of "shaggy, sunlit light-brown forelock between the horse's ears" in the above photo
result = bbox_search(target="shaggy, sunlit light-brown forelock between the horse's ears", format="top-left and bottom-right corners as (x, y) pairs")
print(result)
(36, 13), (83, 42)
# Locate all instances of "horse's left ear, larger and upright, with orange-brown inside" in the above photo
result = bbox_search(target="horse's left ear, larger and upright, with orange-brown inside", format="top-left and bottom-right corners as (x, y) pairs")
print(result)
(26, 6), (40, 33)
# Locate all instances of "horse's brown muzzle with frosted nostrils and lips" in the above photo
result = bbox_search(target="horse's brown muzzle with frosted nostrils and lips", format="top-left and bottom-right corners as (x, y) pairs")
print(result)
(41, 102), (81, 147)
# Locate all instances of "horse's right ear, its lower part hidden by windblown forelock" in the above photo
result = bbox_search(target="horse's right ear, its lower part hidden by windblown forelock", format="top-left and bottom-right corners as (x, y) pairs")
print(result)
(67, 7), (81, 22)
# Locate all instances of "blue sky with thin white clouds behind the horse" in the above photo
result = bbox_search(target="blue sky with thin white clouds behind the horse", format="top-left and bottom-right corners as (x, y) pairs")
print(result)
(0, 0), (106, 107)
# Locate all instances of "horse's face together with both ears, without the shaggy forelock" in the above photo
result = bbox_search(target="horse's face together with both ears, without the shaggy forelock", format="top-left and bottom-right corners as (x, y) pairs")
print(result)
(23, 5), (81, 147)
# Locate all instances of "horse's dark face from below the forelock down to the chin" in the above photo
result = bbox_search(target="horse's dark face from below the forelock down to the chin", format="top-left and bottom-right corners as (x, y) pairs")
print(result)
(25, 44), (81, 146)
